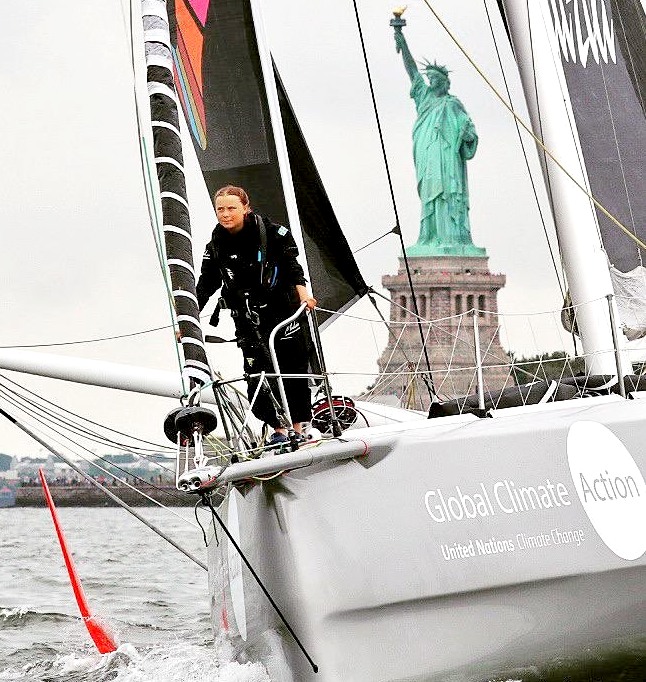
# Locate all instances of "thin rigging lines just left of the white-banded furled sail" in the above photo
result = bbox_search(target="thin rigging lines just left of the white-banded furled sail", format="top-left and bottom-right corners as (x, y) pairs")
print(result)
(129, 0), (187, 394)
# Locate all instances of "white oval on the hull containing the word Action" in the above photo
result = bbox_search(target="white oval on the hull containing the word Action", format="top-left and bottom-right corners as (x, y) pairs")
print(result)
(567, 421), (646, 560)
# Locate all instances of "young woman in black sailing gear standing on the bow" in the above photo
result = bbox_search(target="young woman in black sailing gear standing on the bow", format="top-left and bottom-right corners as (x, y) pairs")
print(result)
(197, 185), (316, 443)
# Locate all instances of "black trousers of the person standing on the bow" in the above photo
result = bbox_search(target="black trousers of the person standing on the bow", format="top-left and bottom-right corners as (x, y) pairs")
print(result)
(238, 315), (312, 429)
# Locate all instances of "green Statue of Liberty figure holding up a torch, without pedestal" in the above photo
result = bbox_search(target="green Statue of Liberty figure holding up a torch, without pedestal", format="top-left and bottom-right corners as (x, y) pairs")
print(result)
(390, 9), (486, 256)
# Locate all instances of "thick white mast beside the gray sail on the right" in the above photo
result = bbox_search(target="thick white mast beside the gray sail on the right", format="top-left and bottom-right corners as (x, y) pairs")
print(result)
(502, 0), (621, 375)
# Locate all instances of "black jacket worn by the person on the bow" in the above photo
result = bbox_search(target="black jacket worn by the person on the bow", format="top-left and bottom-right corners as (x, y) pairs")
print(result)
(197, 213), (305, 314)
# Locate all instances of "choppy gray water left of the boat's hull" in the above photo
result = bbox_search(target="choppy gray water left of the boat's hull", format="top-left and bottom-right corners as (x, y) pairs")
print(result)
(0, 508), (269, 682)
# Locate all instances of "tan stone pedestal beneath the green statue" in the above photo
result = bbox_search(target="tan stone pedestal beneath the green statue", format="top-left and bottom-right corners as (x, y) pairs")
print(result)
(379, 247), (511, 410)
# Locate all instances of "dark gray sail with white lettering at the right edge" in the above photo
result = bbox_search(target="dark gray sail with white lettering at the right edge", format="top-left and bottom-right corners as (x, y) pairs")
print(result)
(549, 0), (646, 272)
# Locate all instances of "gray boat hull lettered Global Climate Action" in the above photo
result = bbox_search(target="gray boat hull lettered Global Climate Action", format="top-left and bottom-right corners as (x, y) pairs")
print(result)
(209, 390), (646, 682)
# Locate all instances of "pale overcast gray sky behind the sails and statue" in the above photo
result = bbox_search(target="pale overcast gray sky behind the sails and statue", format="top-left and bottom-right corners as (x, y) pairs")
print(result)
(0, 0), (560, 454)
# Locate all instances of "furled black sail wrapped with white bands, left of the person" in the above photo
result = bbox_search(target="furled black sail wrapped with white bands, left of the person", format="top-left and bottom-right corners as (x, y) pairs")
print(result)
(141, 0), (211, 384)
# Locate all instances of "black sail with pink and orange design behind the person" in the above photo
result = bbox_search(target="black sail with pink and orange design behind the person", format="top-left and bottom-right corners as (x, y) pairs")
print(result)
(169, 0), (367, 322)
